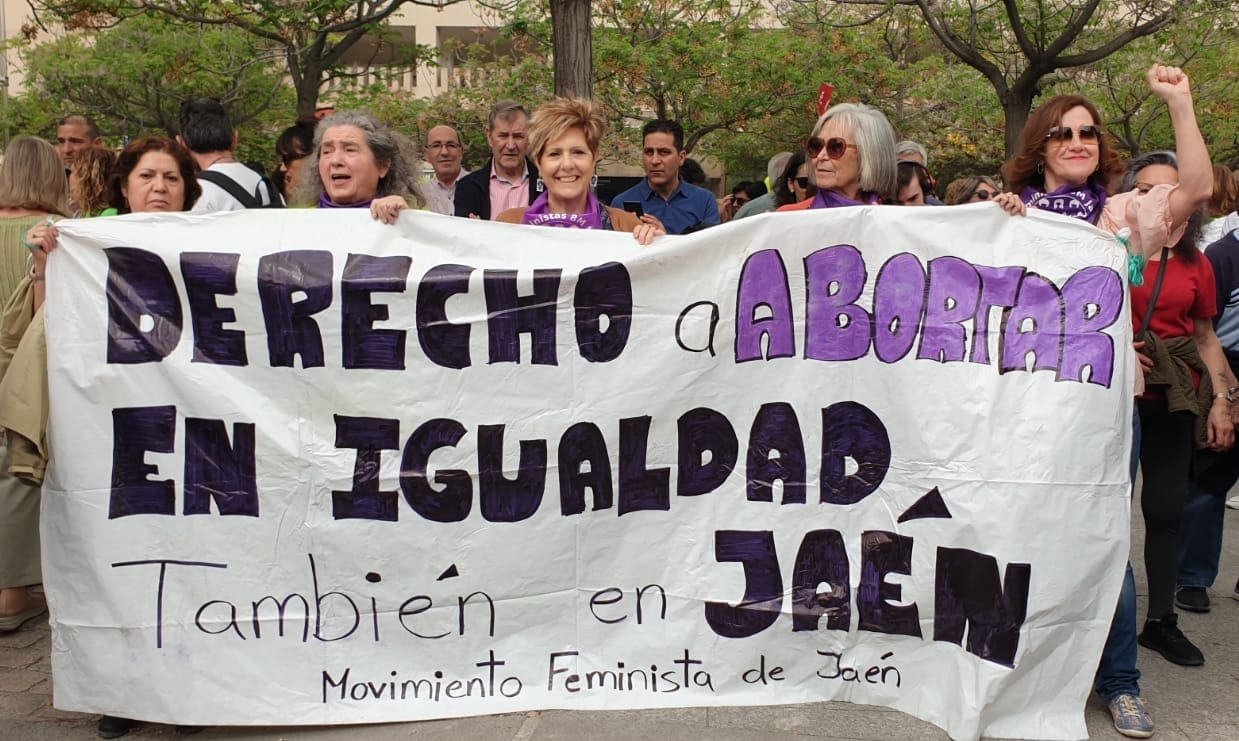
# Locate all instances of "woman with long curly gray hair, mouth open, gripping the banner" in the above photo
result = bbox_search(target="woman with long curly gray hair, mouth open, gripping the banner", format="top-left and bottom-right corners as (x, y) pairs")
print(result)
(296, 110), (424, 223)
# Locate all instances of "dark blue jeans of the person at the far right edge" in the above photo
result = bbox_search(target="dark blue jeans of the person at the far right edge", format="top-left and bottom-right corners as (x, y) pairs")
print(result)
(1178, 447), (1239, 589)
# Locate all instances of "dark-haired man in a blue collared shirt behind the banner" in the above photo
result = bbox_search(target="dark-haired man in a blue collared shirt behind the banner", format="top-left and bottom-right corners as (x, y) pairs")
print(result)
(611, 119), (719, 234)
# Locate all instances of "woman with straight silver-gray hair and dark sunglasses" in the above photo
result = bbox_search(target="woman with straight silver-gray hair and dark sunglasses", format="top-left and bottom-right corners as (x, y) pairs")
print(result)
(778, 103), (896, 211)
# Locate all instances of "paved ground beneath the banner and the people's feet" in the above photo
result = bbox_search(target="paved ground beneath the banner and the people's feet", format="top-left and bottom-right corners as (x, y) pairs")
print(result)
(0, 505), (1239, 741)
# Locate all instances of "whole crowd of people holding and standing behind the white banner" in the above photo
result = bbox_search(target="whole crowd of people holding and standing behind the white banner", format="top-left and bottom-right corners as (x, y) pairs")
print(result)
(0, 64), (1239, 737)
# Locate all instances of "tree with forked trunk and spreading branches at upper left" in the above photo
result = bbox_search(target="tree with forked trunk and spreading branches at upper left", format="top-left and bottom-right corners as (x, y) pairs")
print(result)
(27, 0), (458, 118)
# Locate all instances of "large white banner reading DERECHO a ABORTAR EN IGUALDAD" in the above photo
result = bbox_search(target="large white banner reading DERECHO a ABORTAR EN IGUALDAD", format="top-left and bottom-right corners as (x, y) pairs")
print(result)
(42, 206), (1132, 739)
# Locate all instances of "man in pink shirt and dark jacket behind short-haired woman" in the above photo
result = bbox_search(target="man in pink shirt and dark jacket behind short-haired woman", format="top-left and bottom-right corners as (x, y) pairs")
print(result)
(456, 100), (539, 219)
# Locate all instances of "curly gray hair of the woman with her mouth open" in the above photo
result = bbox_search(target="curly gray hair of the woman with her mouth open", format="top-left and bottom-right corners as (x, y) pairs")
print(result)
(294, 110), (426, 208)
